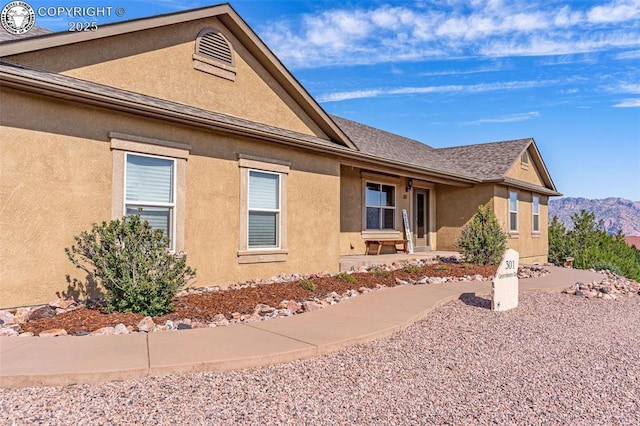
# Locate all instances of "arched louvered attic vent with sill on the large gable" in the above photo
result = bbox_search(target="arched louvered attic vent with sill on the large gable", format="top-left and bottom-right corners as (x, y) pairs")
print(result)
(193, 28), (236, 81)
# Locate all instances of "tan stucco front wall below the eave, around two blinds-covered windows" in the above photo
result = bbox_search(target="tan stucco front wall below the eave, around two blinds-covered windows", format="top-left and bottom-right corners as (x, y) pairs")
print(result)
(0, 89), (340, 307)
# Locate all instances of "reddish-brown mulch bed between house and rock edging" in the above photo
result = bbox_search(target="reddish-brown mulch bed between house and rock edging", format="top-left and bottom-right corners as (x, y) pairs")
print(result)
(20, 264), (497, 335)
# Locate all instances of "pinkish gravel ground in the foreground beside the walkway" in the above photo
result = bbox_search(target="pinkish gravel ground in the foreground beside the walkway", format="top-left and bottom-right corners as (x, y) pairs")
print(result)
(0, 293), (640, 425)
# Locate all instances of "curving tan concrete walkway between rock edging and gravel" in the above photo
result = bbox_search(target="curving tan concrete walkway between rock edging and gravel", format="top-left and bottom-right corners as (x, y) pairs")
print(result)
(0, 267), (602, 388)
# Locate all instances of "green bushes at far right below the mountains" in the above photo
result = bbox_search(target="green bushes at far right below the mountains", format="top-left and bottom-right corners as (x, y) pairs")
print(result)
(549, 210), (640, 281)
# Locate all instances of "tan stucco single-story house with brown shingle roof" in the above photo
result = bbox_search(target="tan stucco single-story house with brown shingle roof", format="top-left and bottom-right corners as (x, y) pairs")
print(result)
(0, 4), (559, 307)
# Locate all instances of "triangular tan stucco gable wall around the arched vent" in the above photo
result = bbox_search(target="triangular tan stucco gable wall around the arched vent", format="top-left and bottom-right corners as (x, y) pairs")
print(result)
(3, 18), (326, 138)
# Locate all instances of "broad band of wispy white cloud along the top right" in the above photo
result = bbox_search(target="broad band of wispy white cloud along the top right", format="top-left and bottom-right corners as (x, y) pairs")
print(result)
(260, 0), (640, 68)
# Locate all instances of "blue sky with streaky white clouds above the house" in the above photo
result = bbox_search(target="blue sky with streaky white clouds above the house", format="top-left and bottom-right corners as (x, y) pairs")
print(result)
(18, 0), (640, 201)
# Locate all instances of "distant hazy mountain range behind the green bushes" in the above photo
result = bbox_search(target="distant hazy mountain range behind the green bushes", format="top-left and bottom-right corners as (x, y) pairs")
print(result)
(549, 197), (640, 236)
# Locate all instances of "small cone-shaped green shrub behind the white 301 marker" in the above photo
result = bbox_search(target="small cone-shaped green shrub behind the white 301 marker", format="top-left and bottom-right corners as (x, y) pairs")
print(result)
(457, 205), (507, 265)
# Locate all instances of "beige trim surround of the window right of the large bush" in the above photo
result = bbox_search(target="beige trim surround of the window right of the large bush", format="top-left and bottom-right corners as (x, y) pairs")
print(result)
(238, 154), (291, 264)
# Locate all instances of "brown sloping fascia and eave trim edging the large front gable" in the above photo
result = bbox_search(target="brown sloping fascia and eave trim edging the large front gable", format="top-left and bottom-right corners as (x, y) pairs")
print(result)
(0, 3), (355, 148)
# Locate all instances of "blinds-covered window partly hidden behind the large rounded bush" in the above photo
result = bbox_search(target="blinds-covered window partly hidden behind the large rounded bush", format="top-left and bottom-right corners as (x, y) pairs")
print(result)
(124, 153), (176, 244)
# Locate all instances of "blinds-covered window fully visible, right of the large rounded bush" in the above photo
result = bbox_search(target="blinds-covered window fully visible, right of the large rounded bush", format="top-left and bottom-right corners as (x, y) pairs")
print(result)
(247, 170), (280, 248)
